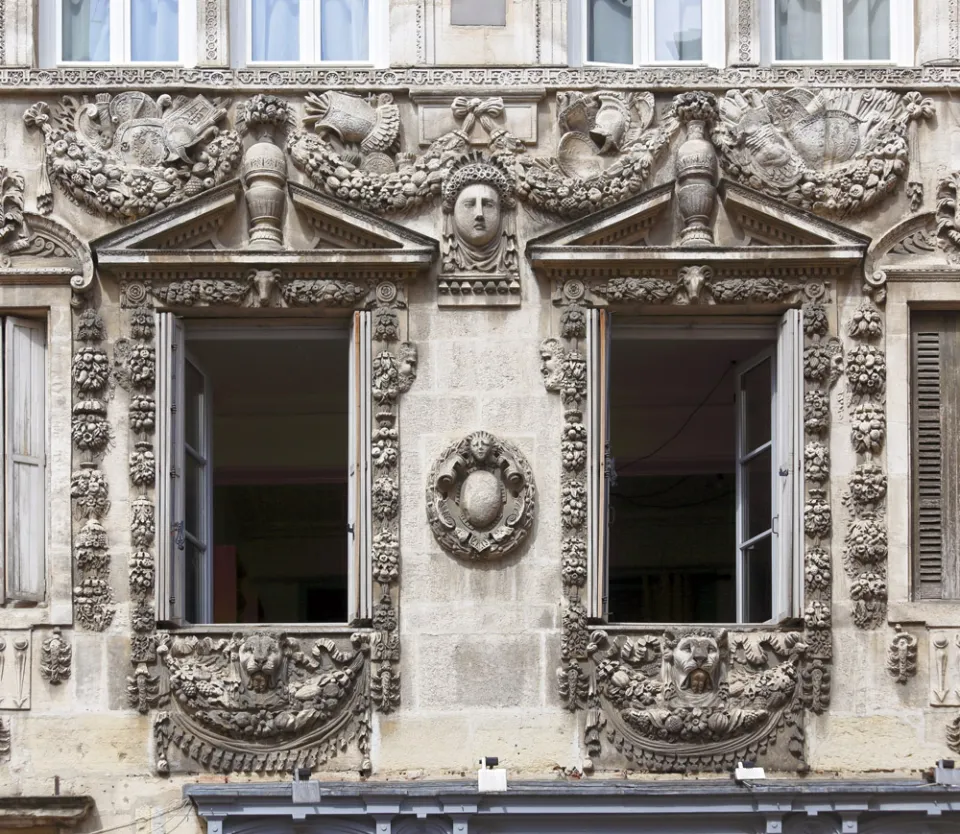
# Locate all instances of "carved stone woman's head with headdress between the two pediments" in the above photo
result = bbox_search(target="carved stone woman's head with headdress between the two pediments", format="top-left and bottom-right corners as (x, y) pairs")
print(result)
(438, 154), (520, 305)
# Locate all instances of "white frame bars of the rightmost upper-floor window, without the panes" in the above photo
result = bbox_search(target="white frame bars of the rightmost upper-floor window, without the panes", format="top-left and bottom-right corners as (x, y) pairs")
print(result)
(759, 0), (915, 67)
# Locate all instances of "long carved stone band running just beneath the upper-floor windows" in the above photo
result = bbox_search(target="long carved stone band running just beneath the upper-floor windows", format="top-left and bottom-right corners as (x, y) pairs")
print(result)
(9, 65), (960, 95)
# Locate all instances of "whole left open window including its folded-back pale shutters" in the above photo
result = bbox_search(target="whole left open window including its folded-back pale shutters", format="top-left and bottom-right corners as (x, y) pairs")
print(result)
(157, 312), (372, 625)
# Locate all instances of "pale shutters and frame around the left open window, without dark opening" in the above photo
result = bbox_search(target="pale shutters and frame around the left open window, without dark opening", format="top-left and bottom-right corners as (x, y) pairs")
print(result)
(156, 311), (373, 626)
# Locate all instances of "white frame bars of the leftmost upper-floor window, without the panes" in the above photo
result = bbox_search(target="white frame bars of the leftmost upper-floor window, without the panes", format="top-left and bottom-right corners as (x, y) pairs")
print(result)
(50, 0), (197, 67)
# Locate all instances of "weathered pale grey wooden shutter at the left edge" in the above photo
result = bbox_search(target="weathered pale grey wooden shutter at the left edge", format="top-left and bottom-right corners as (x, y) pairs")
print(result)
(3, 316), (47, 601)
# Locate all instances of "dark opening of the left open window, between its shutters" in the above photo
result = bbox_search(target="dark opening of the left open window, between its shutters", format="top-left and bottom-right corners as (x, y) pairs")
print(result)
(171, 322), (352, 623)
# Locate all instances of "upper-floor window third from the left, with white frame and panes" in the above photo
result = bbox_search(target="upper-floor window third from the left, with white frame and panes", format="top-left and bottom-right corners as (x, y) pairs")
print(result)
(582, 0), (723, 65)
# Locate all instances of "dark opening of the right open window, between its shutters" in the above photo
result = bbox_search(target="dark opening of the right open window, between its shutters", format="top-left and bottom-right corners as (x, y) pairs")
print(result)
(607, 324), (779, 623)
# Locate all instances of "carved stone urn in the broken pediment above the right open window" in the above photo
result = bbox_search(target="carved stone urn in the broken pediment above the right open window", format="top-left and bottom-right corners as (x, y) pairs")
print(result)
(675, 93), (717, 246)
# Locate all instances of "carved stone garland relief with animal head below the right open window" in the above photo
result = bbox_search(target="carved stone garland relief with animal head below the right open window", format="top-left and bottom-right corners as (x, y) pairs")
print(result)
(586, 629), (807, 772)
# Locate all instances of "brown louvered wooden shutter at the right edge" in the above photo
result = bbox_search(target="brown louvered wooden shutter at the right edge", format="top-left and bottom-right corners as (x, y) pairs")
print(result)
(911, 313), (960, 599)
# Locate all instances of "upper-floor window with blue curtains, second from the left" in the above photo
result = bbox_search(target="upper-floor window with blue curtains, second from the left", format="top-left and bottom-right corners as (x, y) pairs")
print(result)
(246, 0), (378, 64)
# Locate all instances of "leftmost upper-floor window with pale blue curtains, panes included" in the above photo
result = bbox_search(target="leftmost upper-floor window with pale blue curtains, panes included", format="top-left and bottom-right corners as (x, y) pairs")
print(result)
(56, 0), (196, 64)
